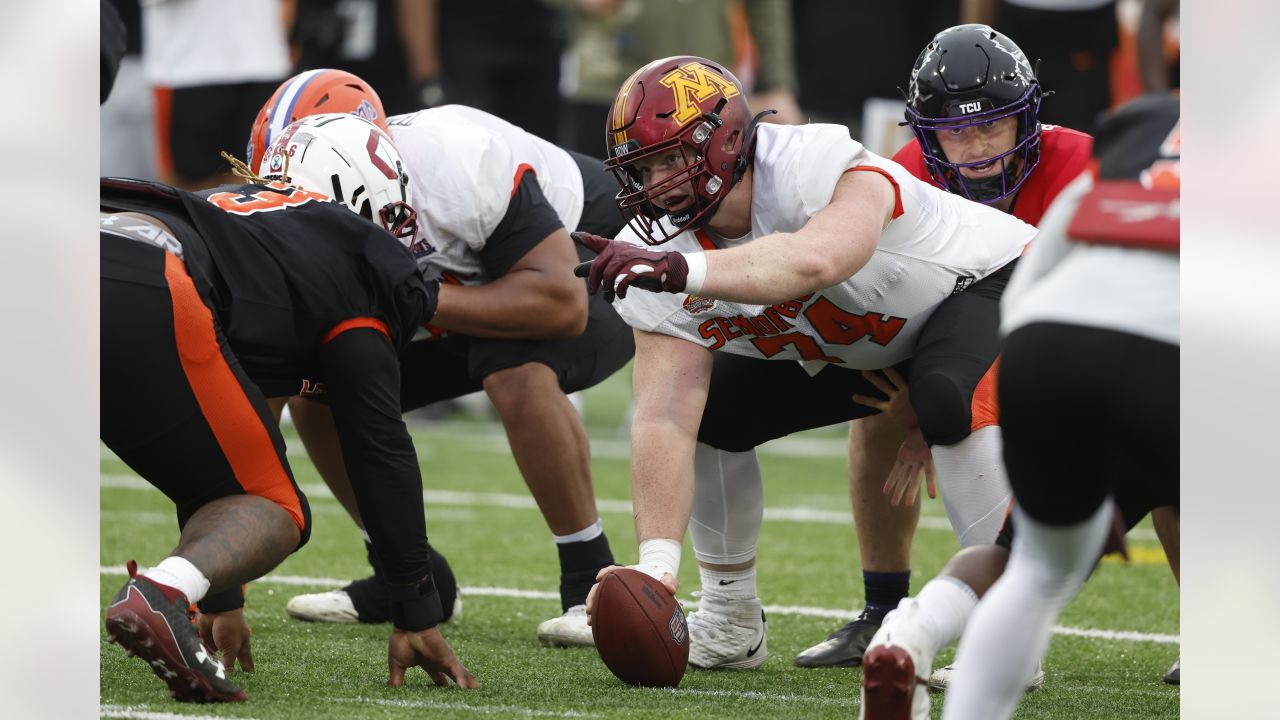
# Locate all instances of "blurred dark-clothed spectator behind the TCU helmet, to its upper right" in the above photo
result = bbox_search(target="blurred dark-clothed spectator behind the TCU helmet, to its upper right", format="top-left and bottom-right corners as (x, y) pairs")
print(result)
(961, 0), (1120, 132)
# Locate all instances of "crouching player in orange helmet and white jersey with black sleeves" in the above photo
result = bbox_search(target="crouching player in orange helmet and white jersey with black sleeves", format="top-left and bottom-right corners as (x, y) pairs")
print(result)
(248, 69), (634, 646)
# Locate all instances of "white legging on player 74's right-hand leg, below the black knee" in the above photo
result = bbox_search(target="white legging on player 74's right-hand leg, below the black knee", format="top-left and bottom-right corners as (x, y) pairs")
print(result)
(933, 425), (1014, 547)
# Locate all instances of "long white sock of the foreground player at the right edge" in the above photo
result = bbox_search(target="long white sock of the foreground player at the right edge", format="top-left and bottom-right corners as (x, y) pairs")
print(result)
(942, 502), (1111, 720)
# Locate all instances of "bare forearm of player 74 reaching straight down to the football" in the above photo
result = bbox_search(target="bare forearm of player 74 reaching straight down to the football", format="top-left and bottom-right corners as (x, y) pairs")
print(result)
(631, 331), (713, 543)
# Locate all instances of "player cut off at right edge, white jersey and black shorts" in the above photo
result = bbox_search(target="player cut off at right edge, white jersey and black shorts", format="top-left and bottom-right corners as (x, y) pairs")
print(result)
(942, 89), (1180, 720)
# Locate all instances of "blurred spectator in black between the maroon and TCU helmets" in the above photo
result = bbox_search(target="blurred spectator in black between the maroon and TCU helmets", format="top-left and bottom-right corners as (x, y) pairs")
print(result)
(792, 0), (959, 141)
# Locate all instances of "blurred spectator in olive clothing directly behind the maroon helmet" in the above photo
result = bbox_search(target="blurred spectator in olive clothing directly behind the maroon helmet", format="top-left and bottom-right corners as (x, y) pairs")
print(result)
(554, 0), (798, 158)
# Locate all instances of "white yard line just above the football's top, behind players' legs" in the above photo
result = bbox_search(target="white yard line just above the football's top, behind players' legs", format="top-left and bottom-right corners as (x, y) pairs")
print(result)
(101, 473), (1156, 541)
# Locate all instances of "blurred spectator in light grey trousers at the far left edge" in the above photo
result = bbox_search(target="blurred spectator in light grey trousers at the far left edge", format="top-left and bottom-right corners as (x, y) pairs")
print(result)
(97, 0), (156, 179)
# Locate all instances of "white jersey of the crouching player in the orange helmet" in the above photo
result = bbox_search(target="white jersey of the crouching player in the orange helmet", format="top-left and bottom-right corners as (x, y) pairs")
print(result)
(387, 105), (582, 284)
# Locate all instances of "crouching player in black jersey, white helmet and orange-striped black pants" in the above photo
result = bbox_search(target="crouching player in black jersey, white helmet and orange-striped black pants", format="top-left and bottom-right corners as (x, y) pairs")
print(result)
(100, 114), (479, 702)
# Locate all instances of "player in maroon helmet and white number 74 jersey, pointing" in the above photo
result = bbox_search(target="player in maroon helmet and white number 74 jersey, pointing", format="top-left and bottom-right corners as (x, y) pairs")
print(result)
(576, 58), (1034, 667)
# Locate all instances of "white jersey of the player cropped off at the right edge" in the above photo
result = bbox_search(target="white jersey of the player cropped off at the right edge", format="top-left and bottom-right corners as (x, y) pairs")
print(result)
(1001, 173), (1180, 345)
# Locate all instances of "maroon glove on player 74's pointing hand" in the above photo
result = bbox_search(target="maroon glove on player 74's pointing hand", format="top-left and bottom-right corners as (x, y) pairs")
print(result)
(573, 232), (689, 302)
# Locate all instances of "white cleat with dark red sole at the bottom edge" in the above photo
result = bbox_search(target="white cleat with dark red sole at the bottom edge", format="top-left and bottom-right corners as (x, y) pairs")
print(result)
(858, 598), (933, 720)
